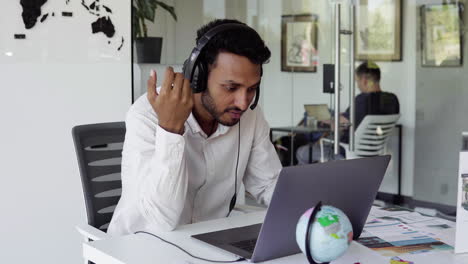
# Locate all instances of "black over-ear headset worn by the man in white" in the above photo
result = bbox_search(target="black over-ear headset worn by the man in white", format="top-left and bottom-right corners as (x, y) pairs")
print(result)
(182, 23), (263, 110)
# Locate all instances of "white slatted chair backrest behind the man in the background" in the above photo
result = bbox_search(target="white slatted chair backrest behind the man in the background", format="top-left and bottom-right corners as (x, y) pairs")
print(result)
(354, 114), (400, 157)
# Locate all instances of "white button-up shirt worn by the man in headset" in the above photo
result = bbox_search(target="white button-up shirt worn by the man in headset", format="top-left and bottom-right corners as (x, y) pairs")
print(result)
(108, 94), (281, 235)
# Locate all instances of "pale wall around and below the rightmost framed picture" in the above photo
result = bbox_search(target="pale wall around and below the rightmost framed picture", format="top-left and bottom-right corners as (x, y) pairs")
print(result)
(414, 0), (468, 205)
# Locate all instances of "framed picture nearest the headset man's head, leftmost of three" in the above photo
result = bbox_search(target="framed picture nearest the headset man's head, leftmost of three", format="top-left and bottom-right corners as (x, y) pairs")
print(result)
(281, 14), (318, 72)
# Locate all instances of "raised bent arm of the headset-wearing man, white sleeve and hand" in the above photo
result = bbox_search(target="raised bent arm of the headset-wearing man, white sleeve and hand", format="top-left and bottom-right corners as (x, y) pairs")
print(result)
(122, 67), (193, 230)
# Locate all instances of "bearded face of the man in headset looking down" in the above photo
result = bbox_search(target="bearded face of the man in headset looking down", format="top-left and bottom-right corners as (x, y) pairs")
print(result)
(201, 52), (261, 126)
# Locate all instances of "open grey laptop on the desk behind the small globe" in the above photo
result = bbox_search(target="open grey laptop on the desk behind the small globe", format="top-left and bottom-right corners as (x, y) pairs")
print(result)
(192, 155), (390, 262)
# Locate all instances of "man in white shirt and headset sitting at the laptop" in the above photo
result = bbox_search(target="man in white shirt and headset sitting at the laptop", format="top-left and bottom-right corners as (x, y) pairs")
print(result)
(108, 20), (281, 235)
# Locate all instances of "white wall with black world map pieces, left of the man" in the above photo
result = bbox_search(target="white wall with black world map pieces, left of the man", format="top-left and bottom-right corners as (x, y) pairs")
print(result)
(0, 1), (131, 263)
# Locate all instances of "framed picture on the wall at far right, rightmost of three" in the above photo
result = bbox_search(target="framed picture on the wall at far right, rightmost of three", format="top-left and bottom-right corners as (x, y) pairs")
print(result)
(421, 3), (463, 67)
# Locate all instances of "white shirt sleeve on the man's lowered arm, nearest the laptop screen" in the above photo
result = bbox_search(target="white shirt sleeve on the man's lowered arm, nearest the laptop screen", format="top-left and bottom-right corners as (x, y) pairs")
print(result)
(244, 109), (281, 205)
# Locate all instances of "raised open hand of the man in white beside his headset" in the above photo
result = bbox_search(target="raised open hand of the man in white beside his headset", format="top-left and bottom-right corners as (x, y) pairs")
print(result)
(148, 67), (193, 135)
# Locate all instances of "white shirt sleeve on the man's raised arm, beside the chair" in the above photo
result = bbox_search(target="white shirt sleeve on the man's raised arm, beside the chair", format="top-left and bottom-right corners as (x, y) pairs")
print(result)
(122, 105), (188, 230)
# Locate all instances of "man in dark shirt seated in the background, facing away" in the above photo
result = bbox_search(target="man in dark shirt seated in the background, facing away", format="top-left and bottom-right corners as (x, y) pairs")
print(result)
(296, 61), (400, 164)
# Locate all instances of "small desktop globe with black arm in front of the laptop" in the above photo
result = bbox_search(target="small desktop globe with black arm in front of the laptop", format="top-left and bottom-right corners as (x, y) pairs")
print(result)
(296, 202), (353, 264)
